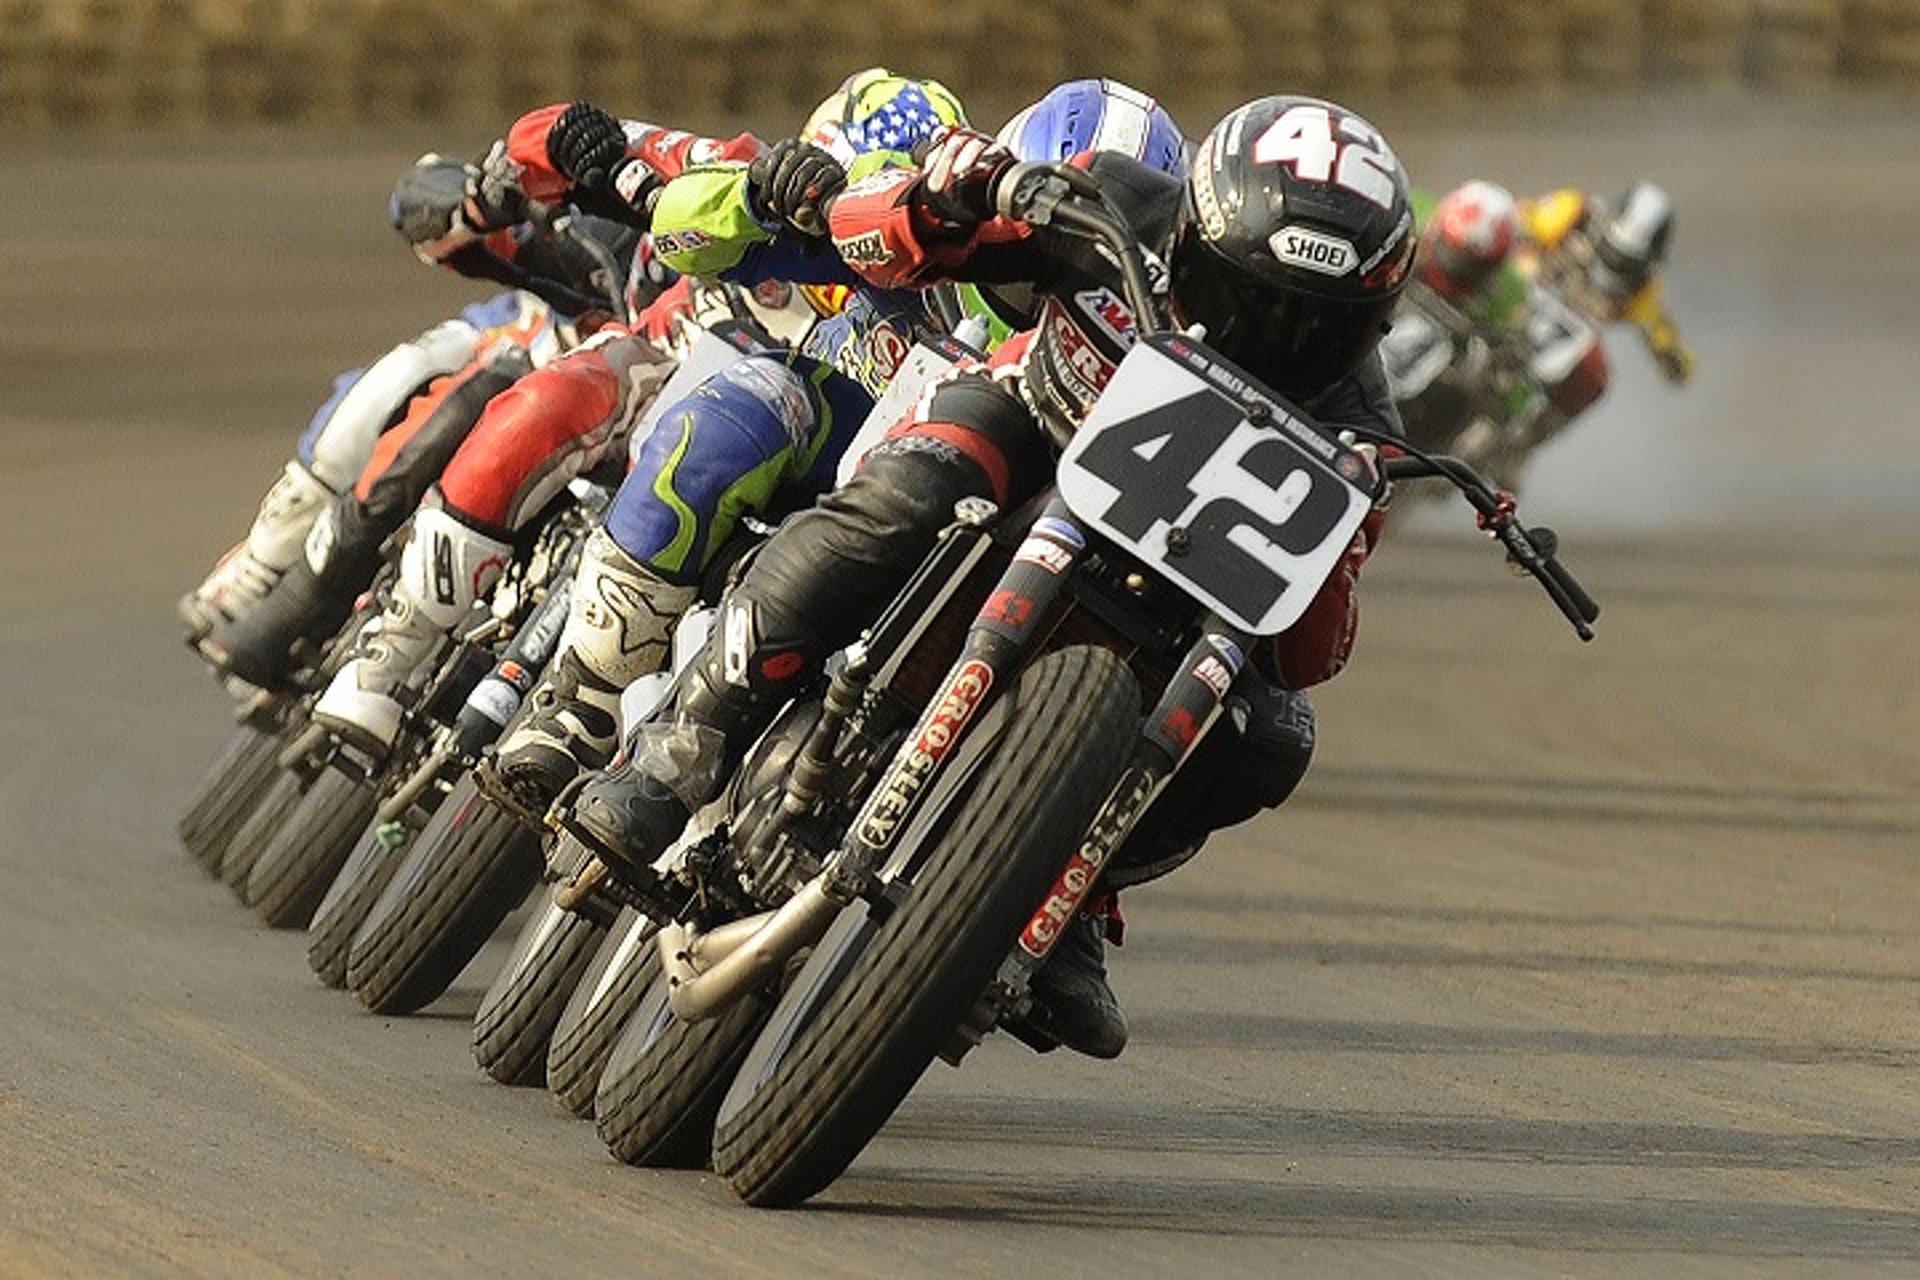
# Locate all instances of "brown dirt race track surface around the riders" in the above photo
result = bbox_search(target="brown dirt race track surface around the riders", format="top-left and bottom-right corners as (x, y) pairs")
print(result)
(0, 104), (1920, 1280)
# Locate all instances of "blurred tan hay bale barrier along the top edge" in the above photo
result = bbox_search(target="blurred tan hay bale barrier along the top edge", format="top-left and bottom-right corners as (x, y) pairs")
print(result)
(0, 0), (1920, 132)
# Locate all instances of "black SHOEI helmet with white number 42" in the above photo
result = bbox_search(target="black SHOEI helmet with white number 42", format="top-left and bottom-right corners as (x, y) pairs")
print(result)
(1167, 96), (1415, 401)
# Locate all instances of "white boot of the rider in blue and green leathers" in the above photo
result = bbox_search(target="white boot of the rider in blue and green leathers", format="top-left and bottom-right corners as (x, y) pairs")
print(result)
(480, 530), (695, 814)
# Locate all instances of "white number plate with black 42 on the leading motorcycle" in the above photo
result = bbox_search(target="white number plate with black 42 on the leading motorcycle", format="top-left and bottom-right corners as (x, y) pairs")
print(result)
(1060, 334), (1373, 635)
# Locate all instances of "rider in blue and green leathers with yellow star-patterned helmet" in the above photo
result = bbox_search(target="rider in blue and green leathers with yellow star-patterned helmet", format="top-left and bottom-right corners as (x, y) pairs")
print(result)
(480, 67), (966, 816)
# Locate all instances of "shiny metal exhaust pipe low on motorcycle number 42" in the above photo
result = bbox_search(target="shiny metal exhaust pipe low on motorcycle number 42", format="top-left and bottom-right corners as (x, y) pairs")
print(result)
(657, 875), (841, 1023)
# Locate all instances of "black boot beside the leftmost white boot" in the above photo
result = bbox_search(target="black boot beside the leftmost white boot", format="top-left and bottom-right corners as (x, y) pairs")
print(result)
(198, 493), (384, 689)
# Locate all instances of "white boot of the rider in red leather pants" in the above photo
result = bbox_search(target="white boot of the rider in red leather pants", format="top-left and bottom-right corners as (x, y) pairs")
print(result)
(313, 507), (513, 756)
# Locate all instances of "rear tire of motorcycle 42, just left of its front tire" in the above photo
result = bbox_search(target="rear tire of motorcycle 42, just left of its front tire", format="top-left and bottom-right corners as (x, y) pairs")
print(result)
(593, 973), (772, 1169)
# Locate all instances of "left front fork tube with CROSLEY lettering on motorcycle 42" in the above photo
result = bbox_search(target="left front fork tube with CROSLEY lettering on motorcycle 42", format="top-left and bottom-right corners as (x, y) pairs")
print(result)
(826, 497), (1087, 904)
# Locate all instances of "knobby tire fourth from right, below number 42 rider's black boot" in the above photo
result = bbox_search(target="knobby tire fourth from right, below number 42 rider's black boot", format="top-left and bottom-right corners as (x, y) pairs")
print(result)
(474, 894), (607, 1084)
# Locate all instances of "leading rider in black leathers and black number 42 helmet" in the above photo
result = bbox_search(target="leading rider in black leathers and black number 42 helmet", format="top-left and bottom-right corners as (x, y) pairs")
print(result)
(555, 96), (1415, 1057)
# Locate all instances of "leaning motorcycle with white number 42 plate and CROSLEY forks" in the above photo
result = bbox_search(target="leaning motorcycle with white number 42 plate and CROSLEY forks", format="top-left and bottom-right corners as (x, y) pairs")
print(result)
(537, 165), (1597, 1205)
